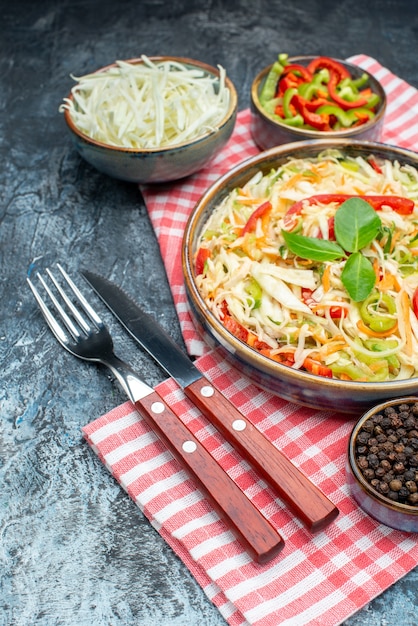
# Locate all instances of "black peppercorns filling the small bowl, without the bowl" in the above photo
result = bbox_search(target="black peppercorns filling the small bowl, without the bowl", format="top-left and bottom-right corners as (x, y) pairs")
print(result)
(355, 402), (418, 506)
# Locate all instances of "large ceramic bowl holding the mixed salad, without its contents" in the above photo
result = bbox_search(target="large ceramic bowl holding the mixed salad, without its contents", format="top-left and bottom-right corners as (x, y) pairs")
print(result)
(182, 139), (418, 415)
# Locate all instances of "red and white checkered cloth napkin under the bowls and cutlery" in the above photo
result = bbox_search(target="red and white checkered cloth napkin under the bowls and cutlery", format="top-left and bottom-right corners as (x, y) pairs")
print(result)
(83, 55), (418, 626)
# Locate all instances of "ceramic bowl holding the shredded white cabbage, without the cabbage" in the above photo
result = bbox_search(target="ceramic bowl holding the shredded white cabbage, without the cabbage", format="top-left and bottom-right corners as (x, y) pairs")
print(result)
(64, 56), (238, 184)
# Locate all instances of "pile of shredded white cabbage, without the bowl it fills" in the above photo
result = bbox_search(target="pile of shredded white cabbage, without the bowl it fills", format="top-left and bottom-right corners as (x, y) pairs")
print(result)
(59, 55), (230, 149)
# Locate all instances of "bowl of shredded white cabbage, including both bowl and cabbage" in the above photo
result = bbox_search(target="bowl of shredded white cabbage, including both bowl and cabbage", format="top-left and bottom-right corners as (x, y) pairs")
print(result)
(59, 55), (238, 184)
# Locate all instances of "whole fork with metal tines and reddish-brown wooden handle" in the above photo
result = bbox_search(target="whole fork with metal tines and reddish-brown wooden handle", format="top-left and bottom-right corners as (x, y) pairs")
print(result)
(27, 264), (284, 563)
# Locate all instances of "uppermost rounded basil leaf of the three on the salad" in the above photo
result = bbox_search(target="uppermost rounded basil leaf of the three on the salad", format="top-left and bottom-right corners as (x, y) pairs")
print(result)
(334, 198), (382, 252)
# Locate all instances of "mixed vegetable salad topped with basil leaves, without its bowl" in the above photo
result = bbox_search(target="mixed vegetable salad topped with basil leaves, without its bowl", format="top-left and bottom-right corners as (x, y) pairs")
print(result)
(195, 150), (418, 382)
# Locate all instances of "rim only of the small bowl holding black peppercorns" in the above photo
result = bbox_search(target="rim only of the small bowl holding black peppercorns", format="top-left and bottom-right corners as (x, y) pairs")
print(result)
(347, 396), (418, 521)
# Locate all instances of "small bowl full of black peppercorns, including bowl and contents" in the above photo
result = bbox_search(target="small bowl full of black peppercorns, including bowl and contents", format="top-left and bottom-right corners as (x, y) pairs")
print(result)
(346, 397), (418, 532)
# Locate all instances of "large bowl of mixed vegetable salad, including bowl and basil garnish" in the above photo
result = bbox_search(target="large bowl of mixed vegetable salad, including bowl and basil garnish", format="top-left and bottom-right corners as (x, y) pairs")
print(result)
(183, 139), (418, 414)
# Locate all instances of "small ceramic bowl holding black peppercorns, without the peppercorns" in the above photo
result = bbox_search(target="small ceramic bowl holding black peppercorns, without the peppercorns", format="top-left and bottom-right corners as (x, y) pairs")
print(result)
(346, 396), (418, 532)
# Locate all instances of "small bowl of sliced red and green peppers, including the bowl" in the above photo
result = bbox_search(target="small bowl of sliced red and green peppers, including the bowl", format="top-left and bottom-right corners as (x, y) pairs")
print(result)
(251, 54), (387, 150)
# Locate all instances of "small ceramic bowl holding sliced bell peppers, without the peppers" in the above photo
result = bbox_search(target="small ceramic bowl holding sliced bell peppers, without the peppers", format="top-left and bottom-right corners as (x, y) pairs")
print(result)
(251, 56), (387, 150)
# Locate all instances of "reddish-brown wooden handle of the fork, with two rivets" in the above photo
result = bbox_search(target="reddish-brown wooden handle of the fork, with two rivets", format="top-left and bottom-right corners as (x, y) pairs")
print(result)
(135, 392), (284, 563)
